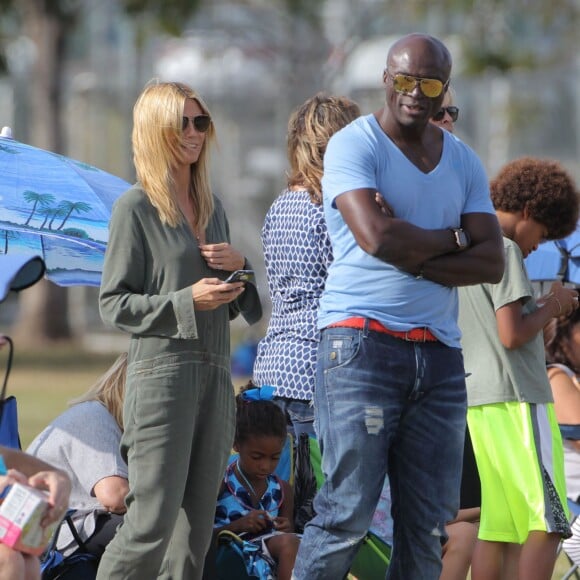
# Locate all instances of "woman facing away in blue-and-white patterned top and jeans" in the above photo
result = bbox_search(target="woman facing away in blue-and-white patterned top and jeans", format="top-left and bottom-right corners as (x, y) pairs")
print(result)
(253, 93), (360, 437)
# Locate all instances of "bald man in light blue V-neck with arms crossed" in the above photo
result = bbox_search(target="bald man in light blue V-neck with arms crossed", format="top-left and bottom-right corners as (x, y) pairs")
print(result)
(293, 34), (503, 580)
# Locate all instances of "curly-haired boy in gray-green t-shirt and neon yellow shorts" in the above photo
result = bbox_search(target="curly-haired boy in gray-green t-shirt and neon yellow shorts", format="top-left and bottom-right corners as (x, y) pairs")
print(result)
(459, 157), (579, 580)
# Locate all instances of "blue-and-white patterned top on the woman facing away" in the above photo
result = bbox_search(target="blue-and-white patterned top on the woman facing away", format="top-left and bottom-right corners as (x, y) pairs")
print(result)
(253, 189), (332, 401)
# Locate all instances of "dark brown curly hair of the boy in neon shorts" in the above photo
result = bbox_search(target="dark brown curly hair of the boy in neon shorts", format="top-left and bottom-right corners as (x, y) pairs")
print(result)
(490, 157), (579, 240)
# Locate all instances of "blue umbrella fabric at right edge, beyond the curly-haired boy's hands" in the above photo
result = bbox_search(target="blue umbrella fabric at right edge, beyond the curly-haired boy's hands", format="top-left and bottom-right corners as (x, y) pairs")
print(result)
(525, 222), (580, 284)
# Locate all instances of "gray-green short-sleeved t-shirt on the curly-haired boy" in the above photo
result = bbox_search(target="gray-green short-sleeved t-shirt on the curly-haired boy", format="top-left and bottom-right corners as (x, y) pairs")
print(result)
(459, 237), (553, 407)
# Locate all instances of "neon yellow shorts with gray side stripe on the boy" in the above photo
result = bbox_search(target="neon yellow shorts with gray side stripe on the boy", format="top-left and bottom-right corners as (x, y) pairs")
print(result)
(467, 401), (570, 544)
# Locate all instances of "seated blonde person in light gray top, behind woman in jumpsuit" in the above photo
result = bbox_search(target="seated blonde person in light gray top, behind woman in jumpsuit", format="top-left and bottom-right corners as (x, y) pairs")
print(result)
(27, 353), (129, 557)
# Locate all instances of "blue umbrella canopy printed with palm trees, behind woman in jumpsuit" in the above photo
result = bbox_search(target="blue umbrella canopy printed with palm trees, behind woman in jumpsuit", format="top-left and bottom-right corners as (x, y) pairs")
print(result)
(0, 131), (130, 286)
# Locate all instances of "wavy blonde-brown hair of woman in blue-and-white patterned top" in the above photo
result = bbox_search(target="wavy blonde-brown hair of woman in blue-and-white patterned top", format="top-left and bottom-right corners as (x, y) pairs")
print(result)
(287, 93), (360, 205)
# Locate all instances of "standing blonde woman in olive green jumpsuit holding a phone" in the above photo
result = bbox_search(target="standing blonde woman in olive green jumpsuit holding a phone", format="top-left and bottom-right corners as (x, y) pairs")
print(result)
(98, 82), (262, 580)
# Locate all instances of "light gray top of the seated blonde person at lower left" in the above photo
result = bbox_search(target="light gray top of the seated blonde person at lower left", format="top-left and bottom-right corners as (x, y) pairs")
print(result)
(27, 401), (128, 555)
